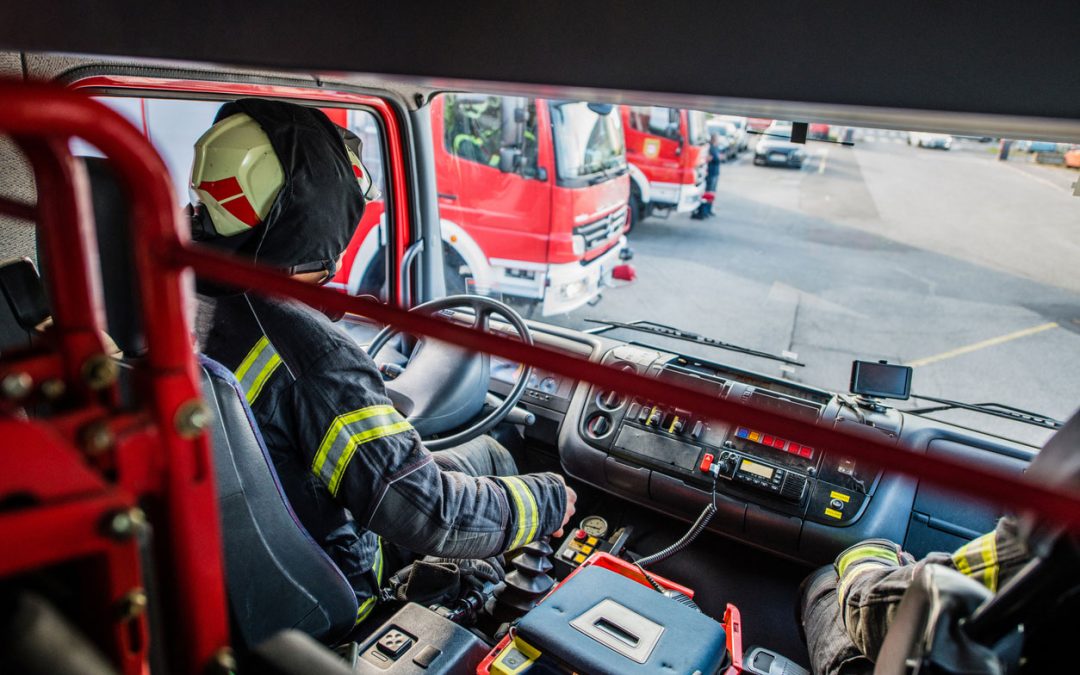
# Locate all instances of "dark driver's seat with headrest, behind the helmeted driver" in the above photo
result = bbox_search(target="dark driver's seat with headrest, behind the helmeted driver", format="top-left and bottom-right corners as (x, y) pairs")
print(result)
(75, 159), (357, 647)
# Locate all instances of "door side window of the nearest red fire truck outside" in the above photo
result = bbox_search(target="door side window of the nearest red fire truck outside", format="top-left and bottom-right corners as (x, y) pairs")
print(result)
(444, 94), (502, 166)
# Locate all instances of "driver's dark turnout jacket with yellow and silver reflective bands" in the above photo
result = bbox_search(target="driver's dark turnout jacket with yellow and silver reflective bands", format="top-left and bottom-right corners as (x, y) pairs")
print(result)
(199, 294), (566, 621)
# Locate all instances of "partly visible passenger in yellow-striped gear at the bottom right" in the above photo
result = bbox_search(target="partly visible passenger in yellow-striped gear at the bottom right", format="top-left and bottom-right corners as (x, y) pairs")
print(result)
(799, 414), (1080, 675)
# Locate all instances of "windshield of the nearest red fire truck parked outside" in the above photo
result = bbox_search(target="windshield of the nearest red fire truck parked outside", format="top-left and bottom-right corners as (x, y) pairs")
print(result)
(551, 102), (626, 179)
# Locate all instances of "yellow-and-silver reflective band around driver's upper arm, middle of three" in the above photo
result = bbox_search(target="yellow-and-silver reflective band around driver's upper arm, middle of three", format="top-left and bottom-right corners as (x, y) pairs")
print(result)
(311, 405), (413, 495)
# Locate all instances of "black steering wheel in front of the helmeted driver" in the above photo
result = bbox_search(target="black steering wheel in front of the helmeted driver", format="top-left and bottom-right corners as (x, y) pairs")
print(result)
(367, 295), (532, 450)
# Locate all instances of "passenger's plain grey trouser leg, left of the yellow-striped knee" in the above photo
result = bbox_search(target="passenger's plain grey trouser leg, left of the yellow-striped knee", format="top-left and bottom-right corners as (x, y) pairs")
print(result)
(799, 565), (874, 675)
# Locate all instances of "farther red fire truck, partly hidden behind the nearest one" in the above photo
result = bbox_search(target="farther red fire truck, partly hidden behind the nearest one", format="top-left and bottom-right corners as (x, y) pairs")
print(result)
(621, 106), (708, 225)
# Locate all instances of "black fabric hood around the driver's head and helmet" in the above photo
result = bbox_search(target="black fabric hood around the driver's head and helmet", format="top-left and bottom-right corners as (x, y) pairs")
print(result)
(192, 98), (364, 280)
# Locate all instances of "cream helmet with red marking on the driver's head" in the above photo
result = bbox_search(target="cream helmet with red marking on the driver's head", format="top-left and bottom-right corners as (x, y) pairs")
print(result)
(191, 112), (379, 237)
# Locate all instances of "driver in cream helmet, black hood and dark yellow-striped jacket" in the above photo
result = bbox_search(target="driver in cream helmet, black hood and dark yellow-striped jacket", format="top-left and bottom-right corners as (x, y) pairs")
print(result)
(191, 99), (576, 622)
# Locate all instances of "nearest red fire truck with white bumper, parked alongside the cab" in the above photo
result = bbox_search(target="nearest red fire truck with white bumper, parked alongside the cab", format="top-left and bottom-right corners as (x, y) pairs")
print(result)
(334, 94), (630, 316)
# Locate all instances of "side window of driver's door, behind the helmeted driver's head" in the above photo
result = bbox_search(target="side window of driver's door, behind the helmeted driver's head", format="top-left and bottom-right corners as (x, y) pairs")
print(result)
(79, 96), (389, 300)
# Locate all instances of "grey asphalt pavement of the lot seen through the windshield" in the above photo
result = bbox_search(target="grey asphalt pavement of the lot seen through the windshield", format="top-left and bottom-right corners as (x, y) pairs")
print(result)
(548, 131), (1080, 444)
